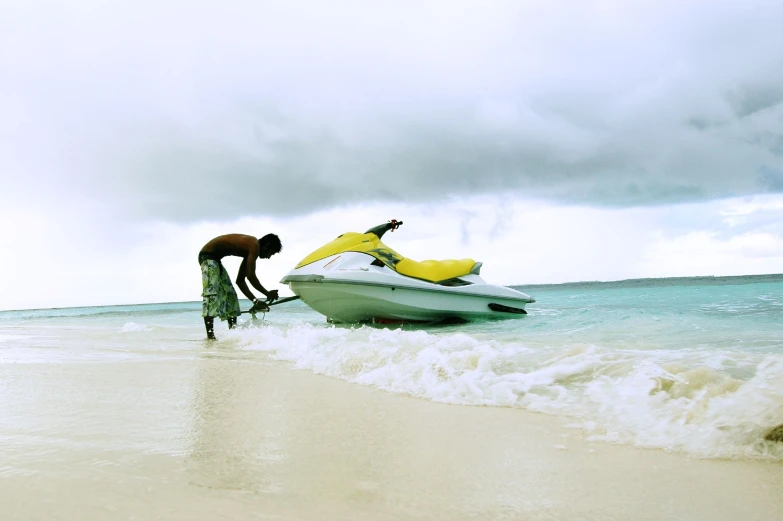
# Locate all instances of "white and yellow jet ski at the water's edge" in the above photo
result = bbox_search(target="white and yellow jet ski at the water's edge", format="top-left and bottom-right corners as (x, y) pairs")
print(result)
(280, 219), (535, 324)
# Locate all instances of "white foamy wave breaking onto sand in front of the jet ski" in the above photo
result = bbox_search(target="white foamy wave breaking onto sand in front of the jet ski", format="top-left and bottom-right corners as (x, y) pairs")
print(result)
(230, 323), (783, 460)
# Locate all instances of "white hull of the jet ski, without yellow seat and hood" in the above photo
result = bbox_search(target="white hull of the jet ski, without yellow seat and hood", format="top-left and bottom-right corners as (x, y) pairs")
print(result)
(281, 252), (534, 322)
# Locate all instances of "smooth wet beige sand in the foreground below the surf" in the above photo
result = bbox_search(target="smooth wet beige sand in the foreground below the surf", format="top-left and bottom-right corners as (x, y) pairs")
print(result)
(0, 349), (783, 521)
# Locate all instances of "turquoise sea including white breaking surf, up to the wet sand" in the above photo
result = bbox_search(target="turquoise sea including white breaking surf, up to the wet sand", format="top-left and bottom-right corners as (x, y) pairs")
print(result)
(0, 276), (783, 460)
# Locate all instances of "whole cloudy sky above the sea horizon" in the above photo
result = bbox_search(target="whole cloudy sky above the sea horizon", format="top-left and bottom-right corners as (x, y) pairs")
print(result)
(0, 0), (783, 309)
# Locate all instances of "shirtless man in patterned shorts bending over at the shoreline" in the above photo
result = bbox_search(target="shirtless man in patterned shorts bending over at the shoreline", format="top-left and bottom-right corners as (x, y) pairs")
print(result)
(198, 233), (283, 340)
